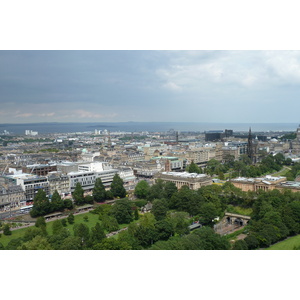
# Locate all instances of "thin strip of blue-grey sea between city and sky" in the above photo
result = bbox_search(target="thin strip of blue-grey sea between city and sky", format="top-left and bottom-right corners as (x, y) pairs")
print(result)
(0, 122), (299, 134)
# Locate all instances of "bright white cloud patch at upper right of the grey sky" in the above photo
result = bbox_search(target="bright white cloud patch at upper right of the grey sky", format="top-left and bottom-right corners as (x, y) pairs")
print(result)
(156, 51), (300, 91)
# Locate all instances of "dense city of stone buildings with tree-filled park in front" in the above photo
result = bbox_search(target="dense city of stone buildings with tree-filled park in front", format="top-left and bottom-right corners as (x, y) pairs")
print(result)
(0, 123), (300, 250)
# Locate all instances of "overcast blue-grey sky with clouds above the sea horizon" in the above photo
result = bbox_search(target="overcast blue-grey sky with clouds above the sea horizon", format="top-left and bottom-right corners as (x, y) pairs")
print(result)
(0, 50), (300, 123)
